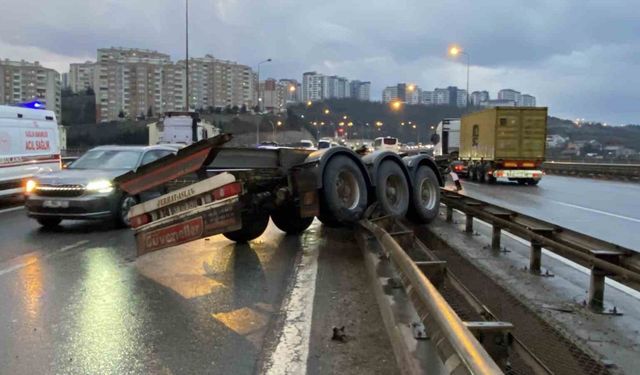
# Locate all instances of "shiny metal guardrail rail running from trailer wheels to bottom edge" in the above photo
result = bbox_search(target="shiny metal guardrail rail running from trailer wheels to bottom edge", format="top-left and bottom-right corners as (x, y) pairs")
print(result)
(361, 221), (503, 374)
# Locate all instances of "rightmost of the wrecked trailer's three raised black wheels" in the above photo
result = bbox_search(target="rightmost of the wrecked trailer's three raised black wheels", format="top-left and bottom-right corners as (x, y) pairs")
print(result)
(409, 166), (440, 224)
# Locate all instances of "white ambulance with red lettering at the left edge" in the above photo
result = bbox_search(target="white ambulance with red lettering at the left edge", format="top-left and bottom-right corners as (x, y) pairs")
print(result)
(0, 105), (60, 198)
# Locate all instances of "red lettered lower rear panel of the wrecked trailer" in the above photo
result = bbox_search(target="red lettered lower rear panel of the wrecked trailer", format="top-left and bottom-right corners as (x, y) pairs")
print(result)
(135, 196), (242, 256)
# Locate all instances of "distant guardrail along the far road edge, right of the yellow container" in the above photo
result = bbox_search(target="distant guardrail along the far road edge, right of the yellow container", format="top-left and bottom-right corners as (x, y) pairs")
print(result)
(542, 161), (640, 180)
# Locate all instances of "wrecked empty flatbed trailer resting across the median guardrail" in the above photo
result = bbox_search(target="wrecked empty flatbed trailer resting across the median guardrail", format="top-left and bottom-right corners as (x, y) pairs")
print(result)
(116, 134), (444, 255)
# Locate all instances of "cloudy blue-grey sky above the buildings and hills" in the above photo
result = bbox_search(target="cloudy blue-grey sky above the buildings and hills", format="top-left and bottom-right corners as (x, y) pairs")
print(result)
(0, 0), (640, 124)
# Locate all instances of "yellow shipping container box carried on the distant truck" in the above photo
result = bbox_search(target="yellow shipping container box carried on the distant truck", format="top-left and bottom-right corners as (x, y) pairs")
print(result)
(459, 107), (547, 161)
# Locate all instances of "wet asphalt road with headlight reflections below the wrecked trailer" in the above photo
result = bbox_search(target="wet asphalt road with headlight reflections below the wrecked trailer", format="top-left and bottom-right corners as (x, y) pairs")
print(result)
(0, 206), (395, 374)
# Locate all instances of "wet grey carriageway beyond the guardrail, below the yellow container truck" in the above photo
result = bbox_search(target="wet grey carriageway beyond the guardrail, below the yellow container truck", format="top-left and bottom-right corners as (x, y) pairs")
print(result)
(452, 175), (640, 251)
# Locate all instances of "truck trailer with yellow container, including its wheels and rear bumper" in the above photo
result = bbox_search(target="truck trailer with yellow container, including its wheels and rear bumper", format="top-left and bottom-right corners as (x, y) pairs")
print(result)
(459, 107), (547, 185)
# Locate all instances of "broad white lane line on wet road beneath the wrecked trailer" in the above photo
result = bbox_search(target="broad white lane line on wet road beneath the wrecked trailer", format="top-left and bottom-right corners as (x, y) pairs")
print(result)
(262, 232), (319, 375)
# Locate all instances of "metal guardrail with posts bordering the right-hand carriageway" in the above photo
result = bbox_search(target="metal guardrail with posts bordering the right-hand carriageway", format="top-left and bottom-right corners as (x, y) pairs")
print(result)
(441, 189), (640, 313)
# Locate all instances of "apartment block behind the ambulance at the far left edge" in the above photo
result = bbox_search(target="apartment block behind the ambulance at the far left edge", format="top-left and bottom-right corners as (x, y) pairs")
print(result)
(0, 59), (62, 119)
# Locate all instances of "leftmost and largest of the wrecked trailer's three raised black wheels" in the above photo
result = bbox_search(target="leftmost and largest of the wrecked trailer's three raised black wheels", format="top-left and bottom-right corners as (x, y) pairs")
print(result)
(320, 155), (368, 226)
